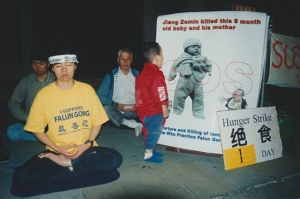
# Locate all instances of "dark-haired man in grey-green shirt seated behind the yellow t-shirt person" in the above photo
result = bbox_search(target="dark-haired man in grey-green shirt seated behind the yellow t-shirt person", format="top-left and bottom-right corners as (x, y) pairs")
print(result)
(7, 51), (55, 142)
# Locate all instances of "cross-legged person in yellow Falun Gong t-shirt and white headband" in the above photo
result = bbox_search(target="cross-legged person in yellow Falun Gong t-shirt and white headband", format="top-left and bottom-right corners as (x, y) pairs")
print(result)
(11, 51), (122, 196)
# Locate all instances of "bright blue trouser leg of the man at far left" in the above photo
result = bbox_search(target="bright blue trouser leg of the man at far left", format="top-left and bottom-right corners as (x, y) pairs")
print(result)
(7, 123), (37, 142)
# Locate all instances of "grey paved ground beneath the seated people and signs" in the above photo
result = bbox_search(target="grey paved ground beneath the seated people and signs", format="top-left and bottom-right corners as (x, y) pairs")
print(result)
(0, 122), (300, 199)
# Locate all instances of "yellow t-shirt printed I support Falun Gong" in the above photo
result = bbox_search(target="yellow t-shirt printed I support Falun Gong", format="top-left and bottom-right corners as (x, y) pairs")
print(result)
(24, 81), (108, 150)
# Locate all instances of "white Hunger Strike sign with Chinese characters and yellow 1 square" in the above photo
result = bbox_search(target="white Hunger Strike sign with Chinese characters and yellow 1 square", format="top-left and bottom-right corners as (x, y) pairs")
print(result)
(217, 107), (282, 170)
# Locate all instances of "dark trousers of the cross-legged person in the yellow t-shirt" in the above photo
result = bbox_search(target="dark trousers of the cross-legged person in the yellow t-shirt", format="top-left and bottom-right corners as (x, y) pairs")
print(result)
(11, 147), (123, 196)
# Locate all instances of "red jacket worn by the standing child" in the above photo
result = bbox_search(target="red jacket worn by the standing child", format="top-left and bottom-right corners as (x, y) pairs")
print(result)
(135, 63), (168, 116)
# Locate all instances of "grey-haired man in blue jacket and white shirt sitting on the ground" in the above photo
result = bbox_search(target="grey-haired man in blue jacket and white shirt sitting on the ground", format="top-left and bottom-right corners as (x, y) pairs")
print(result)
(97, 48), (143, 136)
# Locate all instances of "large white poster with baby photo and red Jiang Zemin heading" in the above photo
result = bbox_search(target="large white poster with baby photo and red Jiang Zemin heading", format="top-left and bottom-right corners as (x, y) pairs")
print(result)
(156, 11), (269, 154)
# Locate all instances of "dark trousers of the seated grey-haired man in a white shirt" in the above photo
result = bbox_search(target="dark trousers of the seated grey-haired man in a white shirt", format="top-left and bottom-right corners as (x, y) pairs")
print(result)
(103, 105), (137, 126)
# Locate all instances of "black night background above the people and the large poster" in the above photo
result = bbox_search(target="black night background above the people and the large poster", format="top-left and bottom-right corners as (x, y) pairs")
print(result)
(0, 0), (300, 79)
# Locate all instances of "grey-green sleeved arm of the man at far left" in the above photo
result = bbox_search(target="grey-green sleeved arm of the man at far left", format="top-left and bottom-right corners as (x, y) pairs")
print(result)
(8, 81), (28, 121)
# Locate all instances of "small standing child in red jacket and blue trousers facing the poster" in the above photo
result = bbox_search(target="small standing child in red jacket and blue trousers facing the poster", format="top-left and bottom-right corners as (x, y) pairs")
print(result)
(135, 41), (169, 163)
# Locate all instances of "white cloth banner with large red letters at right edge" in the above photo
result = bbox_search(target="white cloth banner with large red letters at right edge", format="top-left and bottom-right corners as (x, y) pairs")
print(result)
(268, 33), (300, 88)
